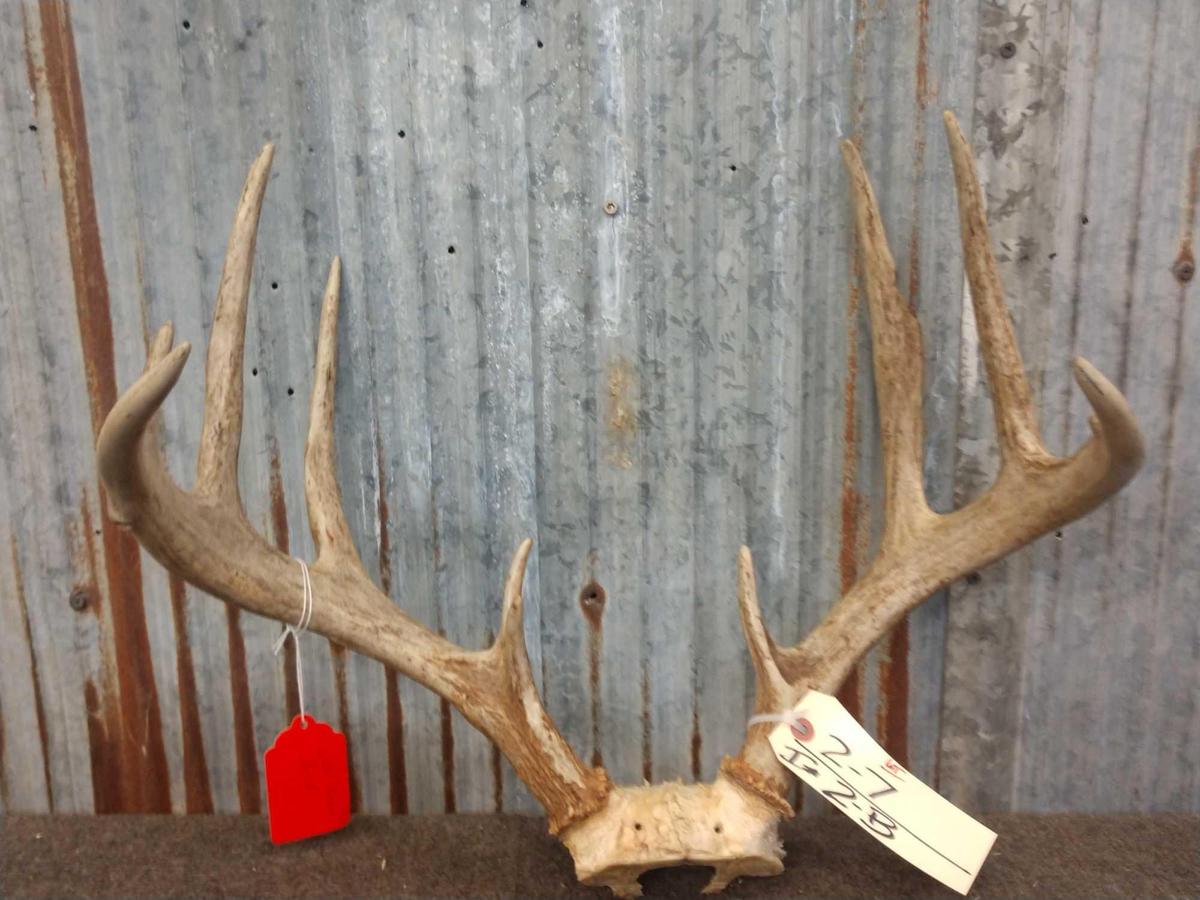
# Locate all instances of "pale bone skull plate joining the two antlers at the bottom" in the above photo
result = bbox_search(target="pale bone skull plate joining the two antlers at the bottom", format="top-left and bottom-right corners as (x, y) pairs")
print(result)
(559, 773), (784, 896)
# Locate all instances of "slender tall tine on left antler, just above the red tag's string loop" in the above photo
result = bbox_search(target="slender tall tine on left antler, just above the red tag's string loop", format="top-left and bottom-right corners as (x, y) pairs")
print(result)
(304, 257), (359, 564)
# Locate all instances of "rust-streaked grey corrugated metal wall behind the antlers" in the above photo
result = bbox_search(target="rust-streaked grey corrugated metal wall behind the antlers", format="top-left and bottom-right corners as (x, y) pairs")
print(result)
(0, 0), (1200, 812)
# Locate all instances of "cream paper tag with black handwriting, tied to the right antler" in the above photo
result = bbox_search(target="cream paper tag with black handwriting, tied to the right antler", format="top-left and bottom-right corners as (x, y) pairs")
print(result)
(770, 691), (996, 894)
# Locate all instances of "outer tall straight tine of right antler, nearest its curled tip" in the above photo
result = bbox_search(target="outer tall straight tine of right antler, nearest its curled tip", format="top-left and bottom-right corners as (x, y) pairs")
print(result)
(942, 110), (1045, 461)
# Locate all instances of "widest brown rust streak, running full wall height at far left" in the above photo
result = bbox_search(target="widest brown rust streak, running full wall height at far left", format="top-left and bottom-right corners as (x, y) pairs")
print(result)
(34, 0), (170, 812)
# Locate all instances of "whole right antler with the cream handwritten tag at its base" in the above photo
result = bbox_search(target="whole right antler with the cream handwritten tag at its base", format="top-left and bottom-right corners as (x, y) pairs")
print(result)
(727, 112), (1144, 811)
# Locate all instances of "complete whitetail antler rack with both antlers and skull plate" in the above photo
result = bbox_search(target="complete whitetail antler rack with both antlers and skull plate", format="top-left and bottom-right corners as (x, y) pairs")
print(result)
(97, 113), (1142, 895)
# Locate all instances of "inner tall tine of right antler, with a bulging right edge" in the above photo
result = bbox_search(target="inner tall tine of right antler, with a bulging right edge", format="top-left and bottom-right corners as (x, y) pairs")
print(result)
(841, 140), (929, 544)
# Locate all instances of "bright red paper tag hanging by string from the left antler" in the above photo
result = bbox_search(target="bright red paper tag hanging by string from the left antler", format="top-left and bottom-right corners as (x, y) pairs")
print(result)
(263, 715), (350, 844)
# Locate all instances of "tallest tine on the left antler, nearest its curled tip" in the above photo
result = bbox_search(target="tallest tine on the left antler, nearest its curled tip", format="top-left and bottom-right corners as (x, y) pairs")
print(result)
(194, 144), (275, 509)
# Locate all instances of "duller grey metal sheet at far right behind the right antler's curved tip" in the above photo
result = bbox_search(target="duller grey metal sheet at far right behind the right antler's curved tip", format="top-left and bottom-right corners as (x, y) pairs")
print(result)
(941, 2), (1200, 810)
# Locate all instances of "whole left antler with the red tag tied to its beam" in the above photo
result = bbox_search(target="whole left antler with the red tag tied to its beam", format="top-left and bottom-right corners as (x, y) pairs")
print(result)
(97, 145), (610, 832)
